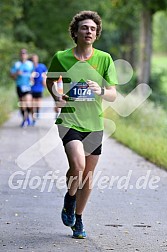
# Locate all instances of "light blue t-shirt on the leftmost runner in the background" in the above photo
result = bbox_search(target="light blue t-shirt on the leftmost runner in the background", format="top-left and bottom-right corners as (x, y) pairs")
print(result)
(10, 60), (34, 92)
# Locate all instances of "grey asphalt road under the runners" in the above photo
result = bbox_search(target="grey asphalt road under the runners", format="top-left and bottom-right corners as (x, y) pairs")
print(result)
(0, 98), (167, 252)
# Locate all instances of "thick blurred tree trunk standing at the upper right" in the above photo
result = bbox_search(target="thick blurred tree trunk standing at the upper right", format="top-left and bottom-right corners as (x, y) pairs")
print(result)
(138, 9), (152, 94)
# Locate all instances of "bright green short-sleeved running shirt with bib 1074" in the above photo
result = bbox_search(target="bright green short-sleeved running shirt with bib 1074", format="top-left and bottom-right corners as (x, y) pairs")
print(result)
(48, 48), (117, 132)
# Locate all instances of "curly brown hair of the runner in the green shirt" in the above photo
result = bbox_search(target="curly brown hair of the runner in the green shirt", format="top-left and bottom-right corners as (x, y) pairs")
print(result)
(69, 11), (102, 43)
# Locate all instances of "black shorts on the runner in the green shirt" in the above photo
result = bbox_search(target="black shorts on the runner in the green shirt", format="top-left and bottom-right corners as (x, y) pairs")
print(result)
(58, 125), (103, 155)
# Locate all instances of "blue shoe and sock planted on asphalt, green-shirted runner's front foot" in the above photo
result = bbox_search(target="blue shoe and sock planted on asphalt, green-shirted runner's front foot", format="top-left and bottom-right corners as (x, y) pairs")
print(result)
(71, 219), (86, 239)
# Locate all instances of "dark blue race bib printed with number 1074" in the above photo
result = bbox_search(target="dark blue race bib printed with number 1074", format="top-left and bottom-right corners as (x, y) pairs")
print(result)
(69, 82), (95, 101)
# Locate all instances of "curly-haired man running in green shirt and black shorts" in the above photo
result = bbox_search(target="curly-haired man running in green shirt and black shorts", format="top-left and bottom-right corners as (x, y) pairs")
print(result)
(47, 11), (116, 238)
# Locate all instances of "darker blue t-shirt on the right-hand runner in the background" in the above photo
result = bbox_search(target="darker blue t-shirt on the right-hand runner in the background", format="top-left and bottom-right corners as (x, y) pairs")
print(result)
(31, 63), (47, 93)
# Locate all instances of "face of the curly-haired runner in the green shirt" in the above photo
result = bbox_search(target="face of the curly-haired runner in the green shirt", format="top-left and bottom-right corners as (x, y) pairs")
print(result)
(76, 19), (97, 45)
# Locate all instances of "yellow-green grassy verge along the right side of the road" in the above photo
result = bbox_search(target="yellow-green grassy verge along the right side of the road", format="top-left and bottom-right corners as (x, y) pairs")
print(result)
(105, 98), (167, 169)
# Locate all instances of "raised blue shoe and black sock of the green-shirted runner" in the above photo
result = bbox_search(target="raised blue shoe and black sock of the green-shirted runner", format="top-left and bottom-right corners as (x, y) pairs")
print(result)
(61, 193), (76, 227)
